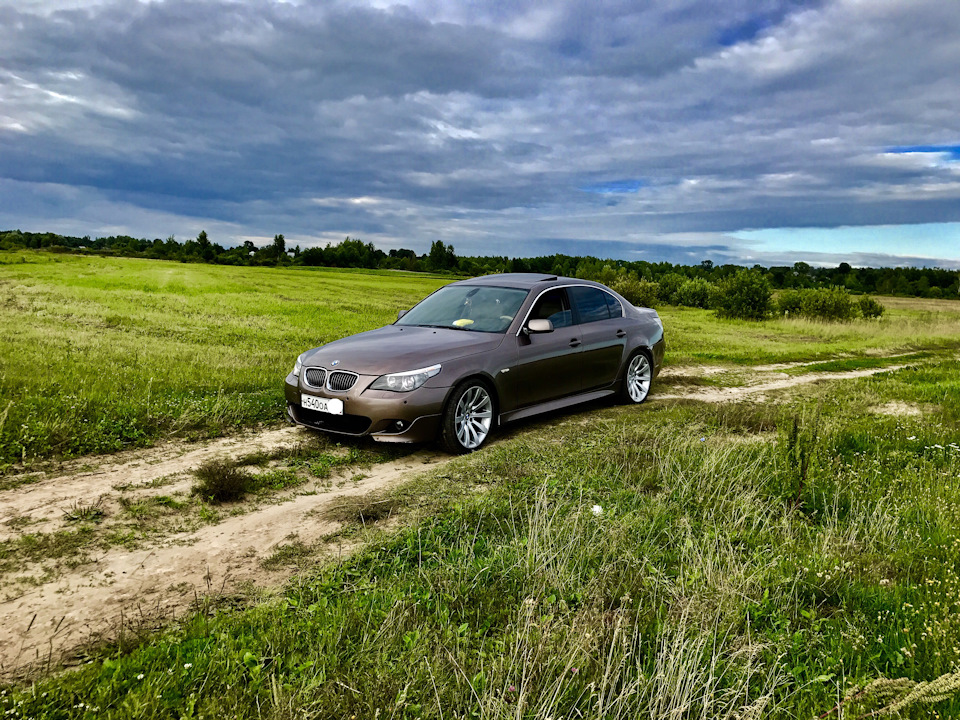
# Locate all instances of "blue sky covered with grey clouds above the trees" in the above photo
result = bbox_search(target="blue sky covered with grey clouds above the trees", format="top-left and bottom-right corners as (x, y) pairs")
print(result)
(0, 0), (960, 268)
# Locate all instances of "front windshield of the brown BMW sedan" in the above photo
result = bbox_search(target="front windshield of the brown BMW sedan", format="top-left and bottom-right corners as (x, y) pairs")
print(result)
(396, 285), (527, 333)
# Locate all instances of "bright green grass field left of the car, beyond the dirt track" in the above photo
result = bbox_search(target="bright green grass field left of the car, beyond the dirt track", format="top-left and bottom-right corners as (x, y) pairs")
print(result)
(0, 253), (449, 468)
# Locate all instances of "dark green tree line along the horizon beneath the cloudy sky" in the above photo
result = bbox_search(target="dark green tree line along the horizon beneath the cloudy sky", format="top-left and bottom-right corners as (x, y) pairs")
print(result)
(0, 230), (960, 299)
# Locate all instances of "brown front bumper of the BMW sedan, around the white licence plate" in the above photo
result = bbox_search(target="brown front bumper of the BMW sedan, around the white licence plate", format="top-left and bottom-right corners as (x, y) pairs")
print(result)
(284, 372), (449, 443)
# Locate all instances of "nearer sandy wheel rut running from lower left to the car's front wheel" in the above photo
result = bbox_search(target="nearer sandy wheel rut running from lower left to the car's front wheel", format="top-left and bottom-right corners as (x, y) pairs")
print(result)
(0, 448), (452, 679)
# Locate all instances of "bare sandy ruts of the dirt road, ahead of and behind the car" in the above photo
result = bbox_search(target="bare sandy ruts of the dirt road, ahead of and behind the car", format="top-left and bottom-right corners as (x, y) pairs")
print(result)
(0, 364), (916, 679)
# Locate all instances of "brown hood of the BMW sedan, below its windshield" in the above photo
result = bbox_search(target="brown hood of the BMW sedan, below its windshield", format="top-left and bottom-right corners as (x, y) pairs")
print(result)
(303, 325), (504, 375)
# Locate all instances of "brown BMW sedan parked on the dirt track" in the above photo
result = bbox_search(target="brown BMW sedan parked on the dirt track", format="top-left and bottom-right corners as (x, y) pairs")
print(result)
(285, 273), (664, 453)
